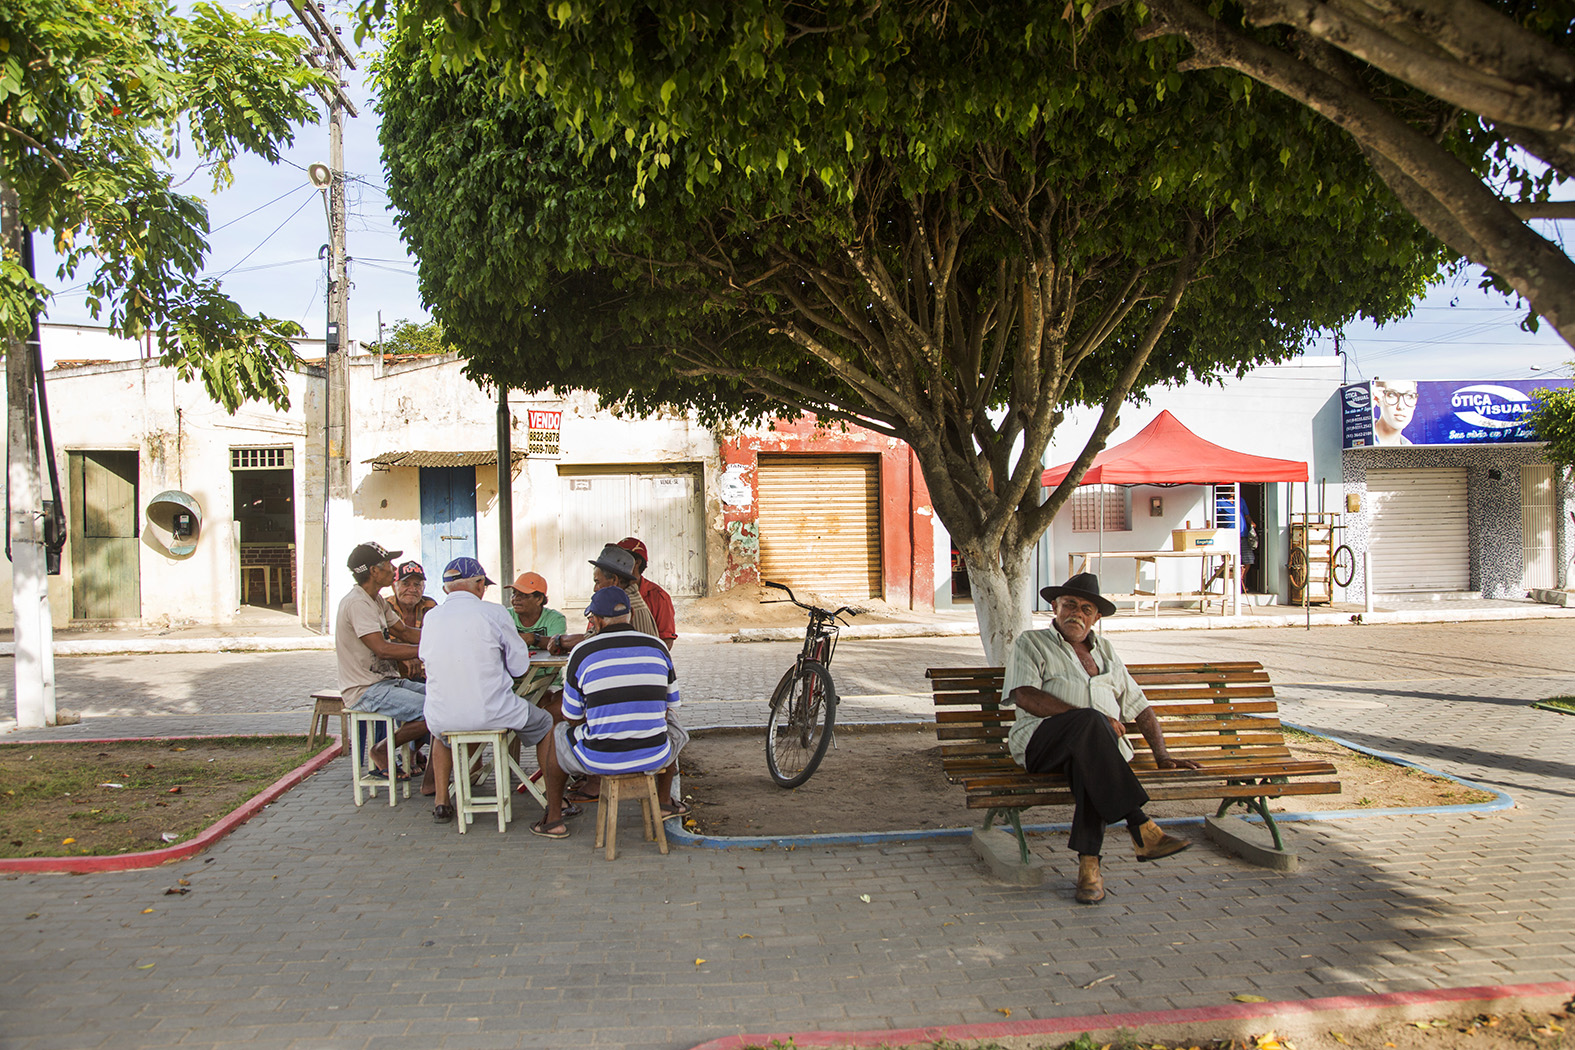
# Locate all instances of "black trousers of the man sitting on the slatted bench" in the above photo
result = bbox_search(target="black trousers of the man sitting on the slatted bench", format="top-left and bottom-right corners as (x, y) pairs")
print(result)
(1022, 707), (1148, 855)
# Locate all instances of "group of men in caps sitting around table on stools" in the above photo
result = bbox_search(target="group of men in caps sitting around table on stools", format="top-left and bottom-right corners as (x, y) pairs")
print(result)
(334, 537), (688, 839)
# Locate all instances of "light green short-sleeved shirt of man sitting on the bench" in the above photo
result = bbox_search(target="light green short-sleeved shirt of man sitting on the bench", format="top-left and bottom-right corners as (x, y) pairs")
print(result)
(1000, 627), (1148, 765)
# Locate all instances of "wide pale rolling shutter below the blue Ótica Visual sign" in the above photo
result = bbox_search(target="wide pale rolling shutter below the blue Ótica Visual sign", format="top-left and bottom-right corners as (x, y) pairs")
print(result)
(1367, 468), (1471, 593)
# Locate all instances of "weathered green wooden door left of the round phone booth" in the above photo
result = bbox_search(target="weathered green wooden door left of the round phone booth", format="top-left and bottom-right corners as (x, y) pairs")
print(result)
(68, 452), (142, 620)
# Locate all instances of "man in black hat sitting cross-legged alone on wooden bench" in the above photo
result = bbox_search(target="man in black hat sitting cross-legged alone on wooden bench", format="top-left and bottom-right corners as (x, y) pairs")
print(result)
(1002, 573), (1199, 904)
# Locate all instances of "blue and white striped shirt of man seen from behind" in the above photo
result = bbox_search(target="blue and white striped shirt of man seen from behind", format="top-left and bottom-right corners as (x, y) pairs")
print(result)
(564, 623), (679, 775)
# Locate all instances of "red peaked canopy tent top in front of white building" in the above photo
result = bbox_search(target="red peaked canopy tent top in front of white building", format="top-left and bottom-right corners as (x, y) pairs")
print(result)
(1040, 411), (1307, 488)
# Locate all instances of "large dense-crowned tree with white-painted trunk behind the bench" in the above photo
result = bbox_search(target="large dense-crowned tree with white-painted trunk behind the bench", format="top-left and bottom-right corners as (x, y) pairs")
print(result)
(380, 0), (1440, 658)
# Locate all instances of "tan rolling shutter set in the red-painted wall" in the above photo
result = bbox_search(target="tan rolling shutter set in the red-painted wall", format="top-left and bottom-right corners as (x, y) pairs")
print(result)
(758, 455), (882, 598)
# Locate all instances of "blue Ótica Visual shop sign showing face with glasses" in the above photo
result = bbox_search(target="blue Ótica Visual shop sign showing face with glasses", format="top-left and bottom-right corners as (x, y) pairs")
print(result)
(1340, 379), (1575, 449)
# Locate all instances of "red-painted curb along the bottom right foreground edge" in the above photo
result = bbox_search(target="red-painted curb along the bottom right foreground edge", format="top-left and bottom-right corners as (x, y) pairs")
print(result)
(693, 981), (1575, 1050)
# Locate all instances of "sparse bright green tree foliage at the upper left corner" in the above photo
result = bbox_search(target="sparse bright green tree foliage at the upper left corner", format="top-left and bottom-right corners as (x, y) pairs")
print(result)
(0, 0), (326, 412)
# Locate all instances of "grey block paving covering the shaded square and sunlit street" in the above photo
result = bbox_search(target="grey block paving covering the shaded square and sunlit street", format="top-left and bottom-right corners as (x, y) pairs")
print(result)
(0, 625), (1575, 1050)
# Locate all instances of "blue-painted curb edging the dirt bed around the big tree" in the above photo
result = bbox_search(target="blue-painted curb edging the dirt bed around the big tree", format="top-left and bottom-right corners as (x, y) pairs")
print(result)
(668, 723), (1515, 850)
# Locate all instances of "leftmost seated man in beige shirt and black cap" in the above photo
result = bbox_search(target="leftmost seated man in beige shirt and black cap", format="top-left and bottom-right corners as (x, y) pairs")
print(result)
(334, 543), (427, 773)
